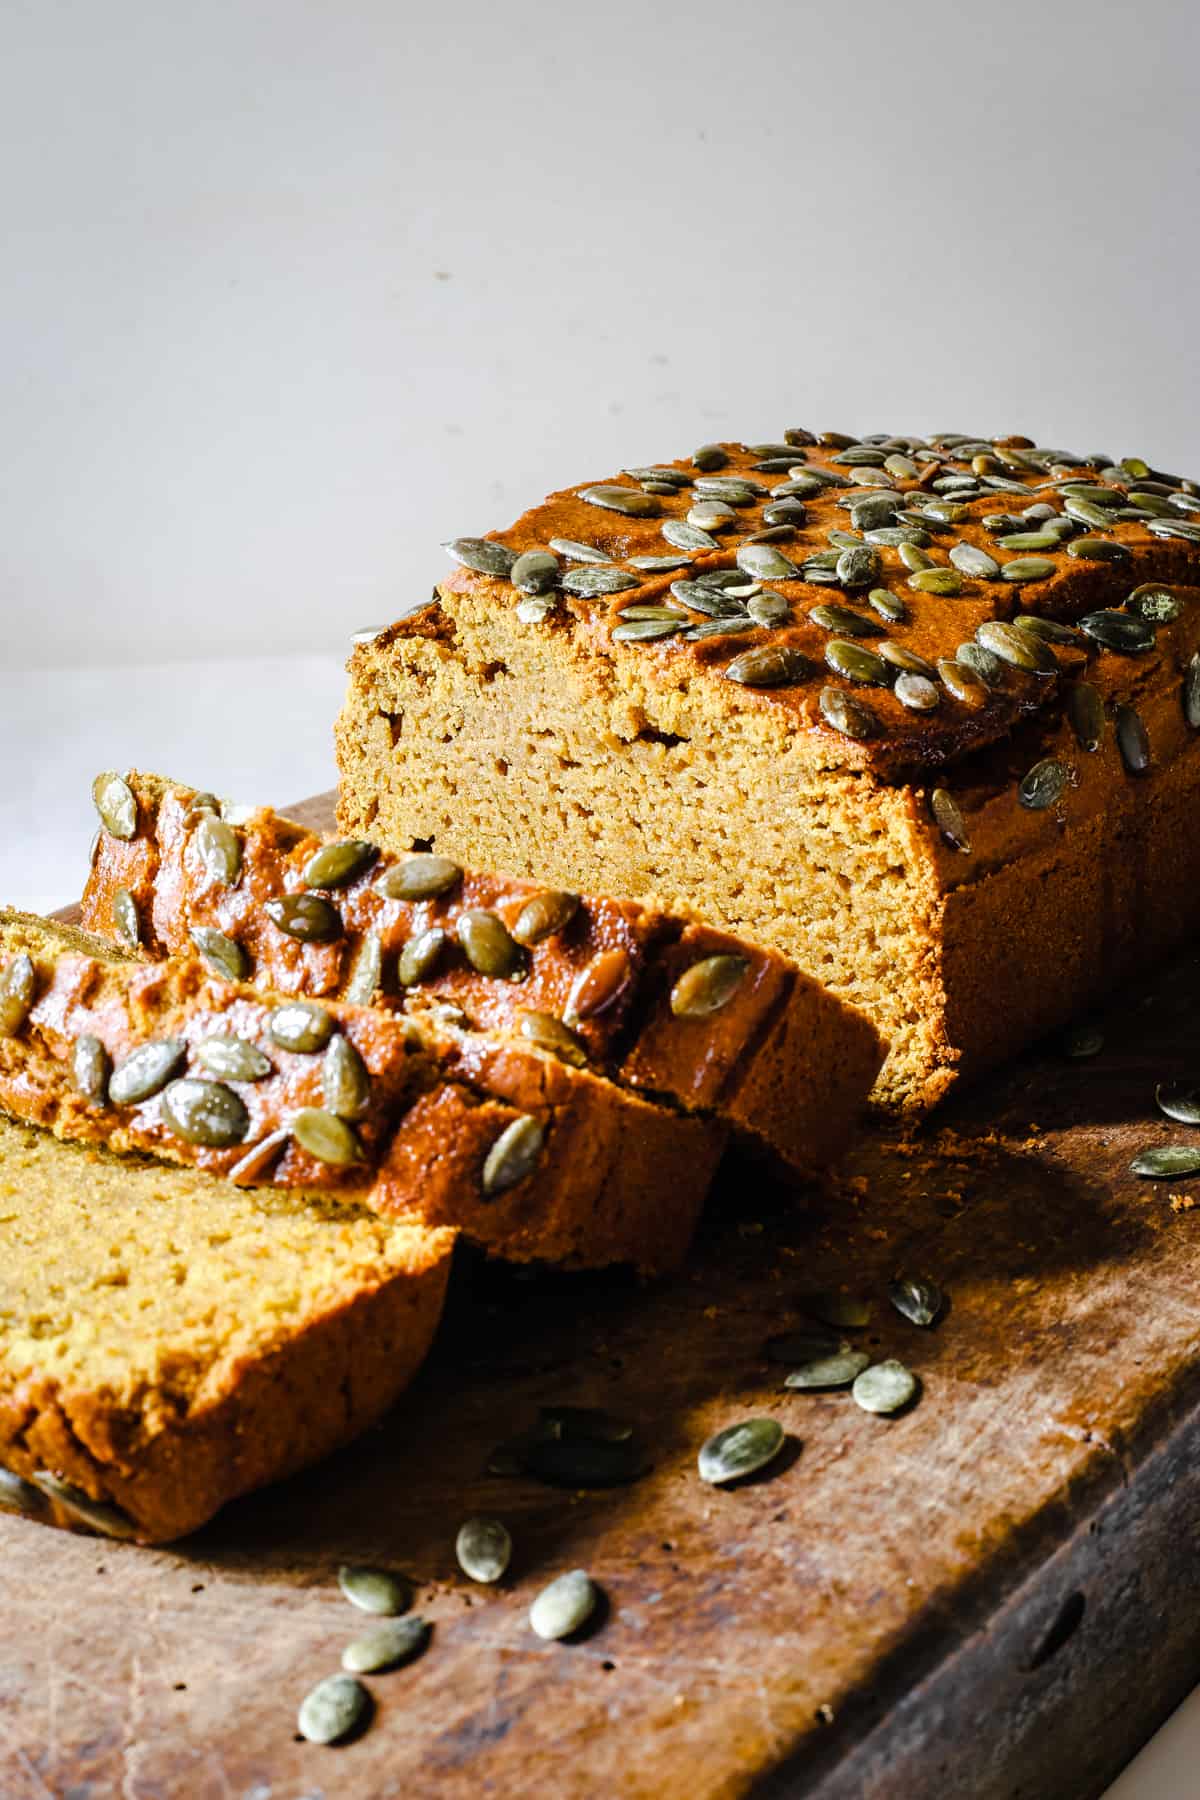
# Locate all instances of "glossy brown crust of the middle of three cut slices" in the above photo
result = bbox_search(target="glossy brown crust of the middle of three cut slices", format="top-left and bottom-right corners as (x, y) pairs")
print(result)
(0, 913), (725, 1271)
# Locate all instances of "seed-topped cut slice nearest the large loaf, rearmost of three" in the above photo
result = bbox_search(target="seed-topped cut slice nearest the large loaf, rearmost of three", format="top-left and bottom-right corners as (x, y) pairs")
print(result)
(83, 774), (883, 1172)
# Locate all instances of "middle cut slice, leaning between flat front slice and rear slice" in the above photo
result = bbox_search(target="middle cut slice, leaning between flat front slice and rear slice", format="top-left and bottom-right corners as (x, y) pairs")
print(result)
(0, 913), (725, 1273)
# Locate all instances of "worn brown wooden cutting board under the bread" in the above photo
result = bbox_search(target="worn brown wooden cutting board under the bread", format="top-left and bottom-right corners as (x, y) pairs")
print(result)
(9, 801), (1200, 1800)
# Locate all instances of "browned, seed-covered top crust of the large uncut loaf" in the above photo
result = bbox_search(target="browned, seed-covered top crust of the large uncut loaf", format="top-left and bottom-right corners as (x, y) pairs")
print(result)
(424, 430), (1200, 781)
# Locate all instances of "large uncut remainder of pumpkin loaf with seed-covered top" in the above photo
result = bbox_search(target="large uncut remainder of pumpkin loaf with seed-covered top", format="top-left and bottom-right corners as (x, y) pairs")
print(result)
(336, 430), (1200, 1109)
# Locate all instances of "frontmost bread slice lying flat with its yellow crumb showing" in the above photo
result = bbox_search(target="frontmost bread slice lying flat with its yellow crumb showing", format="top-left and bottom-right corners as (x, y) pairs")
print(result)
(0, 1118), (455, 1543)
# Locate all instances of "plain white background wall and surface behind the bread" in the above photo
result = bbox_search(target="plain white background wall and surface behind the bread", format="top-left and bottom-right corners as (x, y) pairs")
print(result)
(0, 0), (1200, 1778)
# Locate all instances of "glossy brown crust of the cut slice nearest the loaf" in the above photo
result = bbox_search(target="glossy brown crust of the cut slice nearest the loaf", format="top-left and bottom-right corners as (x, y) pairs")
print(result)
(83, 776), (882, 1170)
